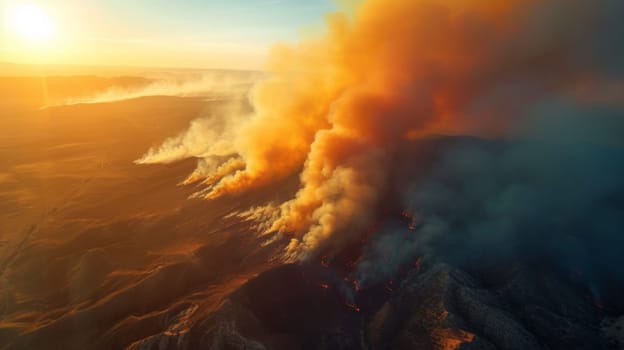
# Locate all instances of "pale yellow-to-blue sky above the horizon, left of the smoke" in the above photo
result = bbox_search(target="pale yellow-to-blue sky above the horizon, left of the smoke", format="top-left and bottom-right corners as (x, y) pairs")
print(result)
(0, 0), (334, 69)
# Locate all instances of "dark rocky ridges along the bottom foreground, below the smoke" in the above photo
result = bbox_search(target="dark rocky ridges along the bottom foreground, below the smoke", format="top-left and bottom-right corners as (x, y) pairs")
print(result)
(131, 263), (617, 349)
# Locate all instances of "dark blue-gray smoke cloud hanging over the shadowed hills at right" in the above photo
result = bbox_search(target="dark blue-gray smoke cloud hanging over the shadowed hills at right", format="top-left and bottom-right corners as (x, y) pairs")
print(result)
(356, 102), (624, 304)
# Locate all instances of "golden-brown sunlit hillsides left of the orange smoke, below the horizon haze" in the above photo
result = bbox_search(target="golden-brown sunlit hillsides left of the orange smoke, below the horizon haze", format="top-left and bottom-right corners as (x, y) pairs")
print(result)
(0, 82), (295, 348)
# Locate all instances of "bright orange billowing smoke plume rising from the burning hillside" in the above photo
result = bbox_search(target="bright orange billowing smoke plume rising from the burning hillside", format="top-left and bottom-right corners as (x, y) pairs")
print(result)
(214, 0), (511, 258)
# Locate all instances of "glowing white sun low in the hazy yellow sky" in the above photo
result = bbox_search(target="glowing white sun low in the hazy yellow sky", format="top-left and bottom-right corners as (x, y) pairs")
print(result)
(8, 4), (56, 43)
